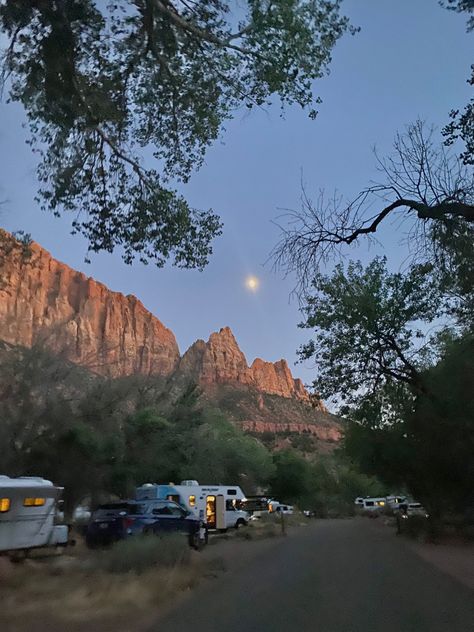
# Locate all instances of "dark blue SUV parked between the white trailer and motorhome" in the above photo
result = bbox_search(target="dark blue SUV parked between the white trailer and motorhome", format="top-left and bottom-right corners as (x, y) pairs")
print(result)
(86, 500), (205, 547)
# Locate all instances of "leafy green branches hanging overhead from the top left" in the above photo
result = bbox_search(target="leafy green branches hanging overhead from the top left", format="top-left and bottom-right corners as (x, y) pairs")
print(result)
(0, 0), (349, 268)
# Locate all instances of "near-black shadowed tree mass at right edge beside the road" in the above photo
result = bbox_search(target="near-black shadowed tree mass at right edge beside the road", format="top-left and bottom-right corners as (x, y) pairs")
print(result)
(344, 335), (474, 520)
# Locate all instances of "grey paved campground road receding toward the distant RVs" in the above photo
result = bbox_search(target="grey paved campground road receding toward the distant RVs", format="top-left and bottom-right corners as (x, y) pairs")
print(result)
(150, 520), (474, 632)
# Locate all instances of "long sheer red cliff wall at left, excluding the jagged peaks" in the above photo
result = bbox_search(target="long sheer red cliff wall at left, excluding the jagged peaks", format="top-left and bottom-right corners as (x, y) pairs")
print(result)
(0, 234), (179, 377)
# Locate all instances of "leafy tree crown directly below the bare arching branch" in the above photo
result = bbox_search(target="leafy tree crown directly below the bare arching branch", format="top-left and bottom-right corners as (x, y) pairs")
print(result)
(299, 258), (440, 414)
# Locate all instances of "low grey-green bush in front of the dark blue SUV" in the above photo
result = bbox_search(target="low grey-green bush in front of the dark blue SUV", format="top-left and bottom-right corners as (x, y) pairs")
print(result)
(98, 534), (191, 574)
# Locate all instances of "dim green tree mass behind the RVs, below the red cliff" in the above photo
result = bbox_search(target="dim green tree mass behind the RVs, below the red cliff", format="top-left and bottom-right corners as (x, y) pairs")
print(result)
(0, 346), (273, 514)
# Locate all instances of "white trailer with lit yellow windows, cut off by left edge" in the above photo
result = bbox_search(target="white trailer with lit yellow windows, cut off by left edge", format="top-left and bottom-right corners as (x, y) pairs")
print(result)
(0, 475), (68, 553)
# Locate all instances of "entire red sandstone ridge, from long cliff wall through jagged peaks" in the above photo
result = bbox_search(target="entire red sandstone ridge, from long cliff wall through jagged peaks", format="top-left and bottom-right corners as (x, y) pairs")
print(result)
(0, 231), (337, 428)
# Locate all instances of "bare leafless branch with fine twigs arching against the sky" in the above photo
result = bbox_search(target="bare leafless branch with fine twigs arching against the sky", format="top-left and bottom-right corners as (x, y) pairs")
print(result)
(272, 121), (474, 292)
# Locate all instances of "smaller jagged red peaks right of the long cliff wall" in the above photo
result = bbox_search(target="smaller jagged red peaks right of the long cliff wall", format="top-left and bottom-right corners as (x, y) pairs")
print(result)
(178, 327), (325, 410)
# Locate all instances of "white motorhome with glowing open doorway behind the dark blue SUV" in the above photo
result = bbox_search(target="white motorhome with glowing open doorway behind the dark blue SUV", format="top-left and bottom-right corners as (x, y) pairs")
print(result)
(135, 480), (249, 530)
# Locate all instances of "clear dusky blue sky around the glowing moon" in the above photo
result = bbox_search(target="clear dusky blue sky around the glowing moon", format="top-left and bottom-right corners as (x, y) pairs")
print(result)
(0, 0), (474, 384)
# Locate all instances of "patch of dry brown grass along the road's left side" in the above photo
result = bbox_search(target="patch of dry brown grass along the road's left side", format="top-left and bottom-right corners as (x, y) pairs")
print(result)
(0, 538), (214, 632)
